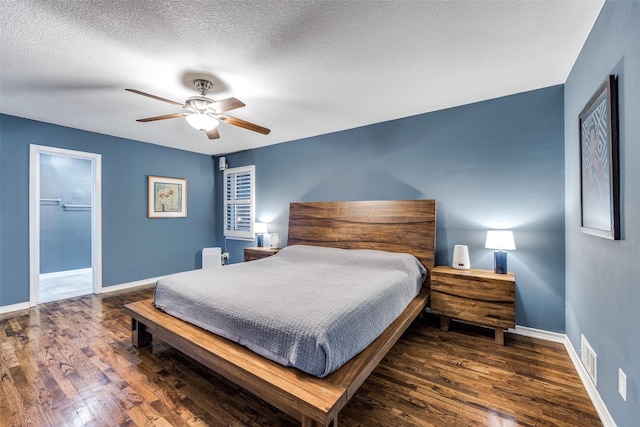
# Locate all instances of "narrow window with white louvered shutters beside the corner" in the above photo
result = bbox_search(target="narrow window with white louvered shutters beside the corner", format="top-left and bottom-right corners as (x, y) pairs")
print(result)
(224, 165), (255, 240)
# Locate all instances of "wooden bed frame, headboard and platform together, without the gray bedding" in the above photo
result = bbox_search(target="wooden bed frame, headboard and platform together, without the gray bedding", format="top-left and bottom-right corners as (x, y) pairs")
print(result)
(125, 200), (436, 426)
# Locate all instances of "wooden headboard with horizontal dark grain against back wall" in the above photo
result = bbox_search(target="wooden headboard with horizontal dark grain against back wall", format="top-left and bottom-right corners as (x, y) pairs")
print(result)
(287, 200), (436, 271)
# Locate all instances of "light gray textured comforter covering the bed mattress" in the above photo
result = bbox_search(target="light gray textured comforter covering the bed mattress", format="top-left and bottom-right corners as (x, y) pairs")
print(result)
(155, 245), (426, 377)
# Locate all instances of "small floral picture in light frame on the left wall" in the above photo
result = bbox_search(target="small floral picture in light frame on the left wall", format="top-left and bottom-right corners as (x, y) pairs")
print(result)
(147, 176), (187, 218)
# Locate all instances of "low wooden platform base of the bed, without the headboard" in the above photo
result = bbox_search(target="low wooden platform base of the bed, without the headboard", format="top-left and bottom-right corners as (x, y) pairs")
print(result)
(124, 288), (429, 427)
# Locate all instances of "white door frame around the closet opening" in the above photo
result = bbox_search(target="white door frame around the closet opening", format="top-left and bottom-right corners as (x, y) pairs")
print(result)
(29, 144), (102, 307)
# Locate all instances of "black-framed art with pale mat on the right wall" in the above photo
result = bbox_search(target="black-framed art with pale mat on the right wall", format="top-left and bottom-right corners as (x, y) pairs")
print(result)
(579, 75), (620, 240)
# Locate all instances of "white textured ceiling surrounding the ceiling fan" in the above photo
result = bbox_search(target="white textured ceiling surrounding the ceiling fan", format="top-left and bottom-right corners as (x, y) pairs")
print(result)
(0, 0), (603, 154)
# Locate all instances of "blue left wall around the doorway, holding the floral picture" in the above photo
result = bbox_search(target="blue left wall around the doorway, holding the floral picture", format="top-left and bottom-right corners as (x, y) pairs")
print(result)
(0, 115), (216, 306)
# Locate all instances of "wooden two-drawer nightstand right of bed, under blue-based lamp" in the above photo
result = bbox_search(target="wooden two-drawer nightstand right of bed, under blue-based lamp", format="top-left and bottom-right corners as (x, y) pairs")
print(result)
(431, 266), (516, 345)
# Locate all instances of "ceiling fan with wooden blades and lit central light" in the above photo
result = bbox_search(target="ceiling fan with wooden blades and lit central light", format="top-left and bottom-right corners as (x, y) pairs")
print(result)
(125, 79), (271, 139)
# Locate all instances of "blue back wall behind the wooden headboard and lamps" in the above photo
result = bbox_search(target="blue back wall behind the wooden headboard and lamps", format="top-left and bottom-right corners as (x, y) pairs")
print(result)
(217, 86), (564, 332)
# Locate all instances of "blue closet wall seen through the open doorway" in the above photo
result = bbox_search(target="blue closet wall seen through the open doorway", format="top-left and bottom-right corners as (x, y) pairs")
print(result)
(40, 154), (93, 274)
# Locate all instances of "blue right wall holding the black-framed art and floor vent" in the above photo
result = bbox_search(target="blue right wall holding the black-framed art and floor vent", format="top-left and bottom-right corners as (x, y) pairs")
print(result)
(565, 1), (640, 426)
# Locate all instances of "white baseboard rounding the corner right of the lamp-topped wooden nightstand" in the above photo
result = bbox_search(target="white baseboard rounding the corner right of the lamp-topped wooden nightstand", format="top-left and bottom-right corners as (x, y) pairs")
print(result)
(508, 325), (616, 427)
